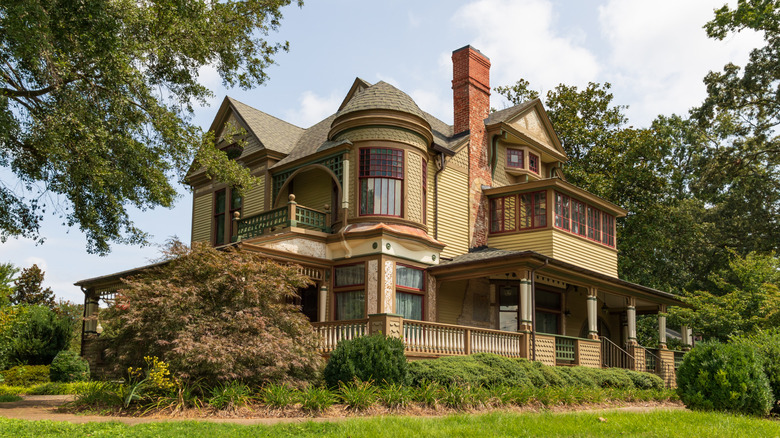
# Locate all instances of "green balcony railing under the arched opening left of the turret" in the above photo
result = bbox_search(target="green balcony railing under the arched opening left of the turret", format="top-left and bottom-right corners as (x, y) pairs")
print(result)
(234, 195), (330, 241)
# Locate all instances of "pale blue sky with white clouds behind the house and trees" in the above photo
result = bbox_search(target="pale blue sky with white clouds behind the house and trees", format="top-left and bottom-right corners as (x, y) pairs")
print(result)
(0, 0), (762, 303)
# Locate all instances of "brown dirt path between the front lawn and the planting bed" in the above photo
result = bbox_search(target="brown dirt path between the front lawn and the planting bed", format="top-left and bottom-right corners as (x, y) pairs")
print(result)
(0, 395), (685, 425)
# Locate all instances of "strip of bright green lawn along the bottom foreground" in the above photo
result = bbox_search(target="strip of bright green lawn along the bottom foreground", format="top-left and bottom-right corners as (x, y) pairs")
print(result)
(0, 411), (780, 438)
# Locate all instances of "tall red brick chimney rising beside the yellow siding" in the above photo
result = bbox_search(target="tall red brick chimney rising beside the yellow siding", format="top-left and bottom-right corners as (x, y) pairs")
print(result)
(452, 46), (493, 247)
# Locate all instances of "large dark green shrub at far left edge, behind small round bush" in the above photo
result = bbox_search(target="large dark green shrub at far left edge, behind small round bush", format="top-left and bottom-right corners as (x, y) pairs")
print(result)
(0, 306), (72, 365)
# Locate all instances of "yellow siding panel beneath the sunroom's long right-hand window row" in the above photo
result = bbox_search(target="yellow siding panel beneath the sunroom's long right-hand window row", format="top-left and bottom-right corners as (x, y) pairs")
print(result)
(552, 230), (617, 277)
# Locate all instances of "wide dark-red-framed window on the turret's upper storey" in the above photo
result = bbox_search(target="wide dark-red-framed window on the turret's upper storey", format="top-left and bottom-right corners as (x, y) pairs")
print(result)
(359, 148), (404, 216)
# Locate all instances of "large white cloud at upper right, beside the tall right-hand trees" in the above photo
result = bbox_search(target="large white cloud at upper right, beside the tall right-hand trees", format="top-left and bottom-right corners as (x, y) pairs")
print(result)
(599, 0), (761, 125)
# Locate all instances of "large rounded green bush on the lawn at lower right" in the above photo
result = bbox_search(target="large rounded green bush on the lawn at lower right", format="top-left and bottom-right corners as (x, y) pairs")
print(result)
(677, 342), (774, 415)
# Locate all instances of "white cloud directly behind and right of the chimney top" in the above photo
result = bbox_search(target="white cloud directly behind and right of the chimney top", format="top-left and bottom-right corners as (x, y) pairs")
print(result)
(453, 0), (600, 106)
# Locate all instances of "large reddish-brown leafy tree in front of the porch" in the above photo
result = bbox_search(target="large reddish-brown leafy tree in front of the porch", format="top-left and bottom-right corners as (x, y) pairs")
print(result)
(101, 242), (322, 384)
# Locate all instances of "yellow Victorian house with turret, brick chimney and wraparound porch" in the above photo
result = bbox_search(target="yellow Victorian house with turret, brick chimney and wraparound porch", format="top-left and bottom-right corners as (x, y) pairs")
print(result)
(77, 46), (692, 379)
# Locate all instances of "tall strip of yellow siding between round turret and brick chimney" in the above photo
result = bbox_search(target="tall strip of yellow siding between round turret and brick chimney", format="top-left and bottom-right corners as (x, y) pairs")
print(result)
(438, 168), (469, 257)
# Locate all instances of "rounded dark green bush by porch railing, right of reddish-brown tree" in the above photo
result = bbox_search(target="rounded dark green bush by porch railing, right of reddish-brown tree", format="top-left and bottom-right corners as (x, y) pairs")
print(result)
(323, 335), (409, 388)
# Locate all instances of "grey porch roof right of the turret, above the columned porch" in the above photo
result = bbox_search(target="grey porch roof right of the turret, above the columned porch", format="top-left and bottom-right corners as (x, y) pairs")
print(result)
(428, 247), (689, 307)
